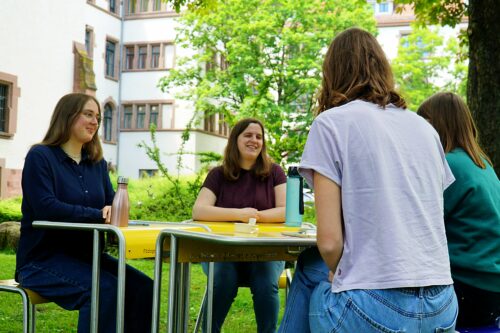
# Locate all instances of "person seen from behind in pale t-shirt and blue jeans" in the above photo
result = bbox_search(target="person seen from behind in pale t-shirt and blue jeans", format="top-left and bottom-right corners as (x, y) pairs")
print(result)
(280, 28), (458, 333)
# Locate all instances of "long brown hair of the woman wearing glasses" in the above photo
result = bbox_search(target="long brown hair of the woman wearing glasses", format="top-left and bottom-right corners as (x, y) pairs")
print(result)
(40, 93), (102, 162)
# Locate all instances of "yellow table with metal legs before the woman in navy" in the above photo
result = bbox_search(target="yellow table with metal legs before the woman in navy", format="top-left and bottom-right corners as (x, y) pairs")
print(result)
(33, 221), (209, 333)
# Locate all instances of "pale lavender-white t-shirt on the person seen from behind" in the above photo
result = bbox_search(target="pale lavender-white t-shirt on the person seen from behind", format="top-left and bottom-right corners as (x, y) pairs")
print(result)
(300, 100), (454, 292)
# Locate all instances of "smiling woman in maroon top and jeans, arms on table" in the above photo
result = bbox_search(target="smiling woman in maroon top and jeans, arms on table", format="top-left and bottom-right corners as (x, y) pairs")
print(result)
(193, 118), (286, 332)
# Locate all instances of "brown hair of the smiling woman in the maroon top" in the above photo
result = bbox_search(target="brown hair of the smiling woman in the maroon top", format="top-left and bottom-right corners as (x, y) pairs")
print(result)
(222, 118), (273, 181)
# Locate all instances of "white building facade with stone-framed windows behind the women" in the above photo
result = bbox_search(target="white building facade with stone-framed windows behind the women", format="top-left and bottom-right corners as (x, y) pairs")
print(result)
(0, 0), (466, 198)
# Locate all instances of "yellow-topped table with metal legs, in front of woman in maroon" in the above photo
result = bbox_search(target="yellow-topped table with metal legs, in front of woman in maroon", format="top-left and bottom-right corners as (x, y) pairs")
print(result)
(151, 221), (316, 333)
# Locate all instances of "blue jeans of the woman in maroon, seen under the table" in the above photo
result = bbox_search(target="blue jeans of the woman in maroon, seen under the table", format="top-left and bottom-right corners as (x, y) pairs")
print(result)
(202, 261), (285, 333)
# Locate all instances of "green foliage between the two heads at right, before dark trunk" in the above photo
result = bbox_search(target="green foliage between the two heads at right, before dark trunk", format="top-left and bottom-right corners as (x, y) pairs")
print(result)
(392, 25), (467, 111)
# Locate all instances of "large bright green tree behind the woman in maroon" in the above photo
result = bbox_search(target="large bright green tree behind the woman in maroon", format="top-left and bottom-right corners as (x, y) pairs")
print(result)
(160, 0), (375, 163)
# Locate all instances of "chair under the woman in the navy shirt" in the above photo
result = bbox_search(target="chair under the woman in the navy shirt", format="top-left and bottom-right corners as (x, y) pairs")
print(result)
(0, 279), (50, 333)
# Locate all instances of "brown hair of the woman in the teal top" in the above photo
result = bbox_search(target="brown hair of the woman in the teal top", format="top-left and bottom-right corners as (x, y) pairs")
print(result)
(417, 92), (492, 169)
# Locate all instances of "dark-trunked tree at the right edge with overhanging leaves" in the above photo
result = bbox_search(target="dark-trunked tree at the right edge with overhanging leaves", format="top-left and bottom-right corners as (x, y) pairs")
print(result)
(394, 0), (500, 174)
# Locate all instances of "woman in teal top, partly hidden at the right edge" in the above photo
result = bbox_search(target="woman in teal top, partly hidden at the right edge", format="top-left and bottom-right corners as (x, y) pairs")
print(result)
(418, 93), (500, 327)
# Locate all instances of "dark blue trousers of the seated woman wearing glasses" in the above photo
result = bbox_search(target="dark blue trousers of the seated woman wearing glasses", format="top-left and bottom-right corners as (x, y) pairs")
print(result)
(18, 254), (153, 333)
